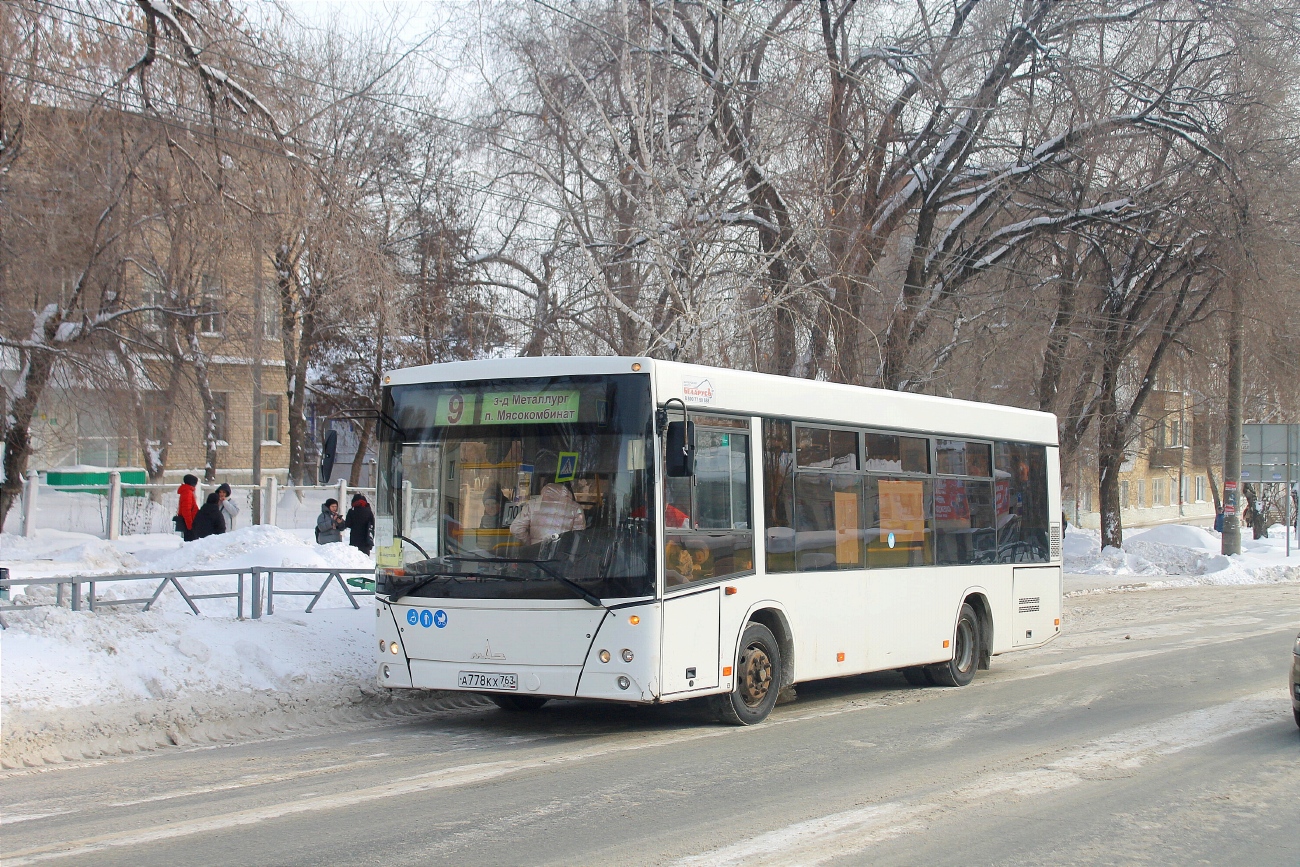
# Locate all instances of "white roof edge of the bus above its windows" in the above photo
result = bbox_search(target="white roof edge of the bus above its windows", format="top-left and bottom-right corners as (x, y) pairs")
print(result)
(384, 356), (1057, 446)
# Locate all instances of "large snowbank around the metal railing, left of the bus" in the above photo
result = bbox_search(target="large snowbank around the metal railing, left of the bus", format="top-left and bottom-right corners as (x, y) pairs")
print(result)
(0, 526), (416, 767)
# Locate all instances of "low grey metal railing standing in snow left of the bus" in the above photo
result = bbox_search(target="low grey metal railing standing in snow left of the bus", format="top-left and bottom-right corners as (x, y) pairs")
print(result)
(0, 567), (374, 629)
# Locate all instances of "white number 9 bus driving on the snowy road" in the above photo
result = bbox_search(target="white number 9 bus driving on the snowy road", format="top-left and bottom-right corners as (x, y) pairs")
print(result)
(376, 357), (1062, 724)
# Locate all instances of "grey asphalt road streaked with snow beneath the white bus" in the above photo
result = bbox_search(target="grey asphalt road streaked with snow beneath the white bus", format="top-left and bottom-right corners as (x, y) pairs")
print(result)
(0, 585), (1300, 867)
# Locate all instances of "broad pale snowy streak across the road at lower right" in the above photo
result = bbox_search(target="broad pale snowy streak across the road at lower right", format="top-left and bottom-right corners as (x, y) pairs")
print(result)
(673, 690), (1287, 867)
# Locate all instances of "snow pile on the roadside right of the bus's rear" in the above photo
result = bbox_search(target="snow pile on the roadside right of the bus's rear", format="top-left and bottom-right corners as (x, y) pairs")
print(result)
(1063, 524), (1300, 586)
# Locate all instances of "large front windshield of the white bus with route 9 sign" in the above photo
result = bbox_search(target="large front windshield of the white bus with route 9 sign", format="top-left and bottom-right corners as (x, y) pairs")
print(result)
(376, 374), (655, 601)
